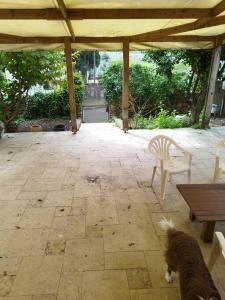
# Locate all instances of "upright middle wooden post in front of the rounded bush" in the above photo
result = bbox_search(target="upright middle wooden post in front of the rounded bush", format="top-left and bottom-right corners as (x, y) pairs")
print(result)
(122, 37), (129, 132)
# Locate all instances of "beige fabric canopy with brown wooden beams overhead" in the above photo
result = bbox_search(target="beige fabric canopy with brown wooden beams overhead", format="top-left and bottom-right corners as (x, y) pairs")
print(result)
(0, 0), (225, 51)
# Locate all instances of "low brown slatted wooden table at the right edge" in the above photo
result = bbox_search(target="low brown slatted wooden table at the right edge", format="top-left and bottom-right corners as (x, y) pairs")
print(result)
(177, 184), (225, 243)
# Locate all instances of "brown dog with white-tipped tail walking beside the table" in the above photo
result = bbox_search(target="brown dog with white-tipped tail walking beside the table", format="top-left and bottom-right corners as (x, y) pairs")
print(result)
(159, 218), (221, 300)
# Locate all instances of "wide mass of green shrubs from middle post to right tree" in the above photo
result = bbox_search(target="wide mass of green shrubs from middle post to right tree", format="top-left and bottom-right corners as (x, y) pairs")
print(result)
(101, 62), (189, 117)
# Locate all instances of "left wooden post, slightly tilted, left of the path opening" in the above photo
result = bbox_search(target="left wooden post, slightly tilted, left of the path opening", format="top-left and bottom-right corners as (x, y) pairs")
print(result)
(65, 37), (77, 133)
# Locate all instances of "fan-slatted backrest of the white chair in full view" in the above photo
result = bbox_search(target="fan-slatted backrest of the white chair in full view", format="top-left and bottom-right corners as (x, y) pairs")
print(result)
(148, 135), (177, 160)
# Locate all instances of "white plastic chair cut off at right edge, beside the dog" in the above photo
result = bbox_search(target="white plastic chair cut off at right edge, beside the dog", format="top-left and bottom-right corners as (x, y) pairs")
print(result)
(208, 232), (225, 271)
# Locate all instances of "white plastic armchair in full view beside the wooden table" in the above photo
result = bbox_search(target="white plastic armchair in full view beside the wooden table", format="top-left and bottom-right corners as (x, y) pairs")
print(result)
(148, 135), (192, 199)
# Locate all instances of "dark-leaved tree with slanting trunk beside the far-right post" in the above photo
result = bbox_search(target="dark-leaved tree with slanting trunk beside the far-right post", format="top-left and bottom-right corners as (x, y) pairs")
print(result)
(144, 49), (225, 124)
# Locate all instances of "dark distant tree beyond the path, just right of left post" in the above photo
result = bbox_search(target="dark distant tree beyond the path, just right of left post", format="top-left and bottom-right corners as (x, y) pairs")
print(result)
(74, 51), (101, 80)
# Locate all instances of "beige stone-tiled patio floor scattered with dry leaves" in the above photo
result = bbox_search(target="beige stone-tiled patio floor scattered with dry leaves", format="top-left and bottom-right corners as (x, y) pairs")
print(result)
(0, 124), (225, 300)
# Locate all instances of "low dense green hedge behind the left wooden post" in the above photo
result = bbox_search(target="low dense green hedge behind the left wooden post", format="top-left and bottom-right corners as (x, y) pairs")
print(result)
(22, 73), (85, 120)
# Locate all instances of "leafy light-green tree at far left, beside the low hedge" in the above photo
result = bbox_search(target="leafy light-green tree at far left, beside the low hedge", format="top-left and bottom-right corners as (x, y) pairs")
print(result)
(0, 51), (65, 131)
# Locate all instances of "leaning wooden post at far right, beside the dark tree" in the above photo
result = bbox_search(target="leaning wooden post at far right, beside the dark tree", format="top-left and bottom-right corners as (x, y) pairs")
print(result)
(202, 45), (221, 128)
